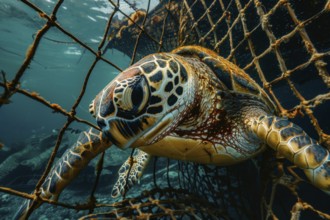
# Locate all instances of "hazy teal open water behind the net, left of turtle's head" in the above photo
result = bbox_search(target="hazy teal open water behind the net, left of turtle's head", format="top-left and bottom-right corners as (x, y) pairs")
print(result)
(0, 0), (157, 145)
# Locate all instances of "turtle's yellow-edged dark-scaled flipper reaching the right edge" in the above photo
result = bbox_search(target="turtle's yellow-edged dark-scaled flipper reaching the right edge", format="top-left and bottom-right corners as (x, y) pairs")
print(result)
(251, 116), (330, 194)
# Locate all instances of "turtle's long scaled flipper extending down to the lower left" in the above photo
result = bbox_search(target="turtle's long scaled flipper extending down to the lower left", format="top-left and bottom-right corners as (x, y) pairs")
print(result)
(14, 128), (111, 219)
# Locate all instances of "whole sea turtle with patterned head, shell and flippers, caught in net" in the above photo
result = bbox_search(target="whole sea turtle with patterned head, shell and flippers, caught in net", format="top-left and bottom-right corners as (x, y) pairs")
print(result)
(16, 46), (330, 218)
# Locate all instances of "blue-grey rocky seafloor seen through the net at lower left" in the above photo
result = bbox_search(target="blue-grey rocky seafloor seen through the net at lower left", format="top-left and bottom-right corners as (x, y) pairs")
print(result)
(0, 130), (186, 220)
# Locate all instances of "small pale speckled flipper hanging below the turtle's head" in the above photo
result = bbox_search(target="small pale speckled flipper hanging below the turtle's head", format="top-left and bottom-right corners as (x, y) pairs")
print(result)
(111, 149), (151, 198)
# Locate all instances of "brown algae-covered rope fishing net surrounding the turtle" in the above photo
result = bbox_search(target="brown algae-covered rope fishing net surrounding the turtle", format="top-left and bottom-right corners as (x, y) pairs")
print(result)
(0, 0), (330, 219)
